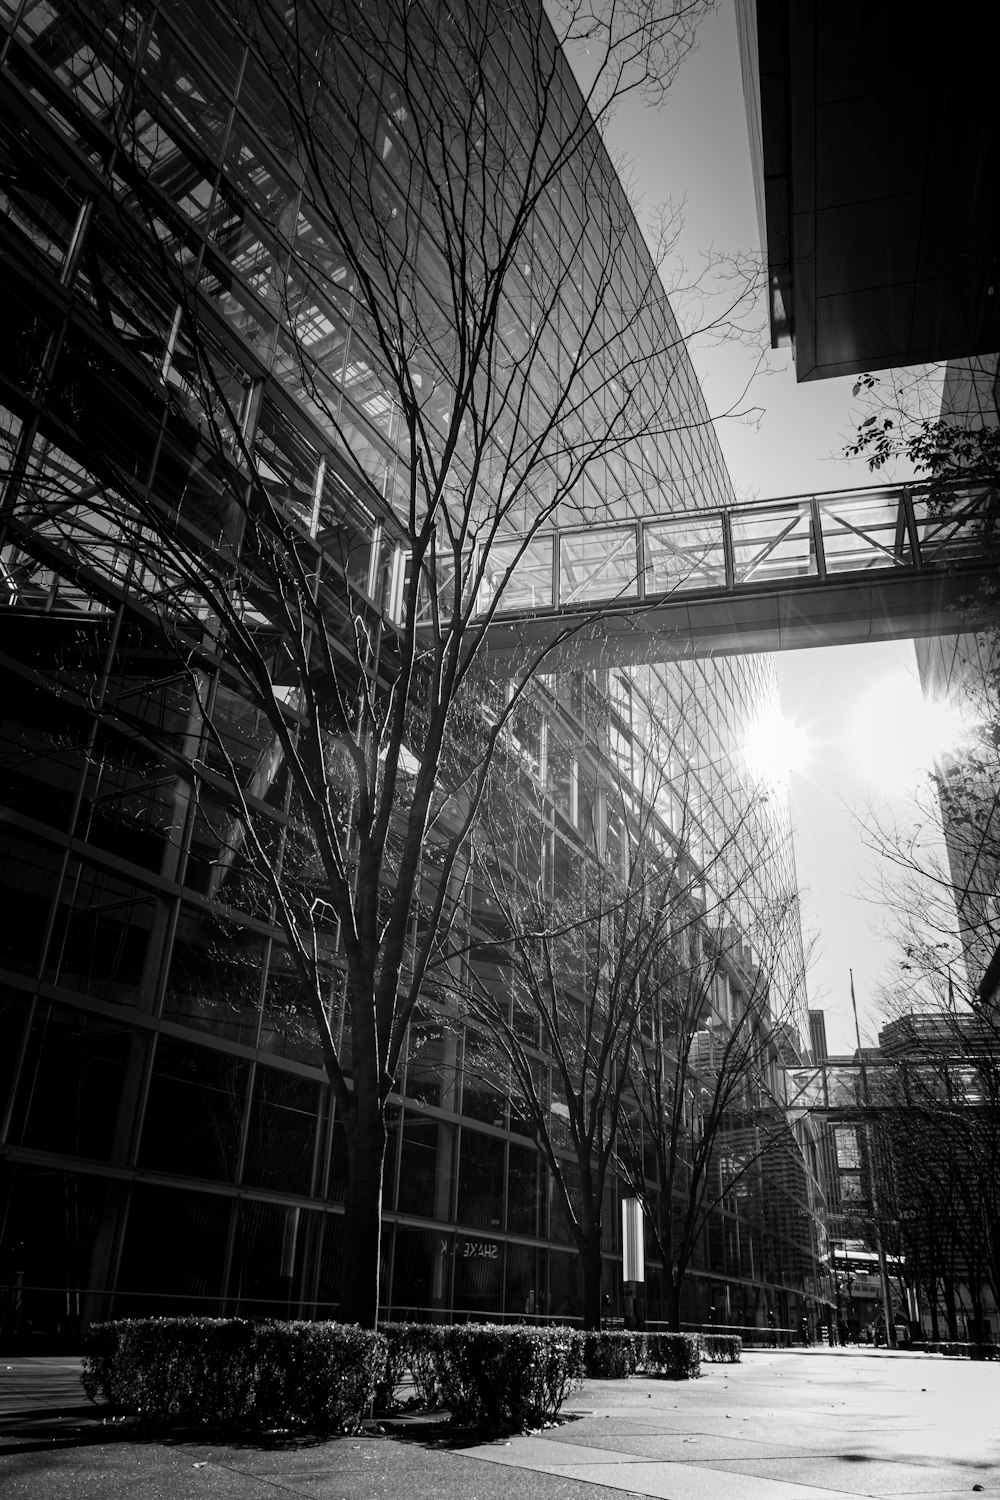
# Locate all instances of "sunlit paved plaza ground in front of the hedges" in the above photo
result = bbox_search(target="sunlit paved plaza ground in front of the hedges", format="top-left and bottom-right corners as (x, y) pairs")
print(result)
(0, 1349), (1000, 1500)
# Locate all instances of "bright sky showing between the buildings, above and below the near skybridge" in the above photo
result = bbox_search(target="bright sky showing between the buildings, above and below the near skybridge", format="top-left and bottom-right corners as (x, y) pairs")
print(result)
(609, 0), (953, 1052)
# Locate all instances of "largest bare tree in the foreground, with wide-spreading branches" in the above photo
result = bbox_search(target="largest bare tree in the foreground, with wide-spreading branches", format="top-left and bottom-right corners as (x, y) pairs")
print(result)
(3, 0), (761, 1325)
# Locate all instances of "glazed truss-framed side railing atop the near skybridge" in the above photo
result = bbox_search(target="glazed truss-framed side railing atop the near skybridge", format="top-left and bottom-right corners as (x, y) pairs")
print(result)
(470, 485), (997, 615)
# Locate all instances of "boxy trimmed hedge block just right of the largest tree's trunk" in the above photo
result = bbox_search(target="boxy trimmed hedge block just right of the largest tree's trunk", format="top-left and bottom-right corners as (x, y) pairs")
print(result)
(436, 1323), (583, 1431)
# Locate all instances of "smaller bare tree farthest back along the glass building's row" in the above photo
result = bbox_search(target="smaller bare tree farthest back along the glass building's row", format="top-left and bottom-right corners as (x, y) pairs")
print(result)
(622, 876), (805, 1329)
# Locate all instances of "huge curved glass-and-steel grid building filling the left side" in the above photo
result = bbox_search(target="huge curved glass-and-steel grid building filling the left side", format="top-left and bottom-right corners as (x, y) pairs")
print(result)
(0, 0), (822, 1328)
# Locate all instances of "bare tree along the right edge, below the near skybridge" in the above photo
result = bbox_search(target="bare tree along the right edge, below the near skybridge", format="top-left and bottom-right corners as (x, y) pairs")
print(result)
(865, 632), (1000, 1338)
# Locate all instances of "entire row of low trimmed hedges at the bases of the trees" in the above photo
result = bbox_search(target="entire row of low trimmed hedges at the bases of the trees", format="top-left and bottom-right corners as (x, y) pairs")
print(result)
(82, 1317), (710, 1433)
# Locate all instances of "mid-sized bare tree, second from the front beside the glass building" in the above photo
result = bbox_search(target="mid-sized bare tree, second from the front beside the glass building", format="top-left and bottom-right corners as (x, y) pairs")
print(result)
(452, 678), (792, 1328)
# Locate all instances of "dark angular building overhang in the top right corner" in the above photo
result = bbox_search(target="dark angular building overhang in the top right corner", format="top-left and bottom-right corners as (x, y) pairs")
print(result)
(736, 0), (1000, 381)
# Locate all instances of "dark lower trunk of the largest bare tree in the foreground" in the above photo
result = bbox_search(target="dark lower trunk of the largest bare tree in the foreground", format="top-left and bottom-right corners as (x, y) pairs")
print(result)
(337, 1085), (385, 1328)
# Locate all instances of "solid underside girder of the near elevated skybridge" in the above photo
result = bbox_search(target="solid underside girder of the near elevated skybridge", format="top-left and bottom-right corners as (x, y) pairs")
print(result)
(486, 563), (999, 672)
